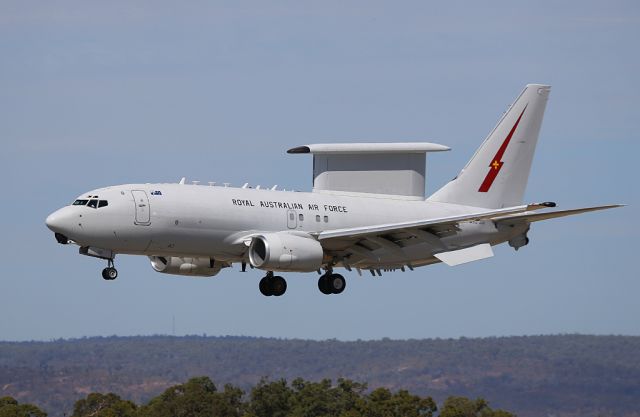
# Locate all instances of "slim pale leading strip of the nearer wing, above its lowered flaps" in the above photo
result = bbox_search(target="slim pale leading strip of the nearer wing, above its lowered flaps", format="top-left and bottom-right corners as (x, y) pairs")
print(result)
(317, 203), (549, 242)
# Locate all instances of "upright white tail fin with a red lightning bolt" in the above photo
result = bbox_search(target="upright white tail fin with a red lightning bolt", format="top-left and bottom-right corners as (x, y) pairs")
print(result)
(429, 84), (551, 208)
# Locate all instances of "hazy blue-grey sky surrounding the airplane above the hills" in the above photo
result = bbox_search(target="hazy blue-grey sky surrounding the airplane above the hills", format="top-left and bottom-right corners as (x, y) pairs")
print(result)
(0, 1), (640, 340)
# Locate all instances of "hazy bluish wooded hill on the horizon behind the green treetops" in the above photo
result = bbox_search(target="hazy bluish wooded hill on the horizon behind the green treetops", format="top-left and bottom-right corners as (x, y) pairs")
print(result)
(0, 335), (640, 417)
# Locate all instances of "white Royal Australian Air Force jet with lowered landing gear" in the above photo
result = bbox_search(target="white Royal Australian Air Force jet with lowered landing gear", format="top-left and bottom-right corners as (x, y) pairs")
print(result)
(46, 84), (622, 296)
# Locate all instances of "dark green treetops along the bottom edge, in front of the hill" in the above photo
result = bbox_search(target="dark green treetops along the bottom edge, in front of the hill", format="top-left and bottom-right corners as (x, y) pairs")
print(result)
(0, 377), (514, 417)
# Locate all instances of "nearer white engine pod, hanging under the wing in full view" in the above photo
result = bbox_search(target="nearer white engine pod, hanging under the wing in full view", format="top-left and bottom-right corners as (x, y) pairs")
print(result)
(249, 232), (324, 272)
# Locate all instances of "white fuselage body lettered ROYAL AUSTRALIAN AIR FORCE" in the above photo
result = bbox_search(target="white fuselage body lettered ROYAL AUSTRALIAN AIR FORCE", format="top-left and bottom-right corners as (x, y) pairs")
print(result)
(47, 184), (521, 268)
